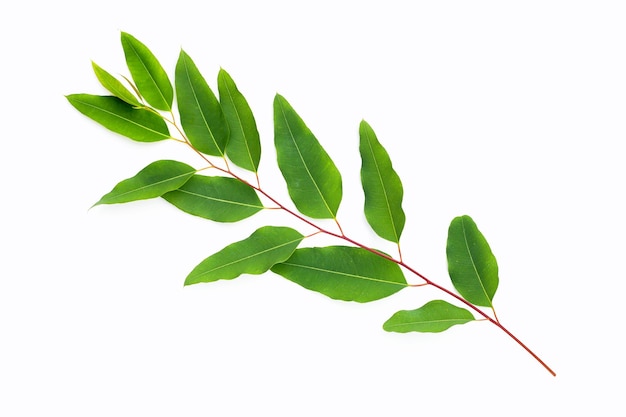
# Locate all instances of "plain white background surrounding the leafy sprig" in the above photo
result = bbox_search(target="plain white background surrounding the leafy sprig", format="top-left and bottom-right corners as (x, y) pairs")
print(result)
(0, 0), (626, 417)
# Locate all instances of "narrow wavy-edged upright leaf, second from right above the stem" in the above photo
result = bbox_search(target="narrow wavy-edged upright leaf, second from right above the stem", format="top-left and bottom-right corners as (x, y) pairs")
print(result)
(359, 120), (405, 243)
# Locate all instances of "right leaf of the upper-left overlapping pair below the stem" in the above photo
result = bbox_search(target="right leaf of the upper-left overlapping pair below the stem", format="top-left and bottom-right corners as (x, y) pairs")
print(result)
(163, 175), (263, 222)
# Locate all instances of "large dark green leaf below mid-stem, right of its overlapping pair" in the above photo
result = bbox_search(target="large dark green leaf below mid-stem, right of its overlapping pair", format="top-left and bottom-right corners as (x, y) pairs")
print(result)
(272, 246), (407, 303)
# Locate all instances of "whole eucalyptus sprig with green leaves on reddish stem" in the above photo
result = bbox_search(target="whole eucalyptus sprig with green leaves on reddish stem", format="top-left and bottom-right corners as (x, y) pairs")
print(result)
(66, 32), (556, 375)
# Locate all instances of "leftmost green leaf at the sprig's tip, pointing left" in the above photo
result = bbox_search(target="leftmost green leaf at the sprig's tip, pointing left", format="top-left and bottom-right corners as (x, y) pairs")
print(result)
(67, 94), (170, 142)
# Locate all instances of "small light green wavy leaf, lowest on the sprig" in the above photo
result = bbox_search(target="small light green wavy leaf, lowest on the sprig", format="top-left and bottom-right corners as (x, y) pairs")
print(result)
(383, 300), (474, 333)
